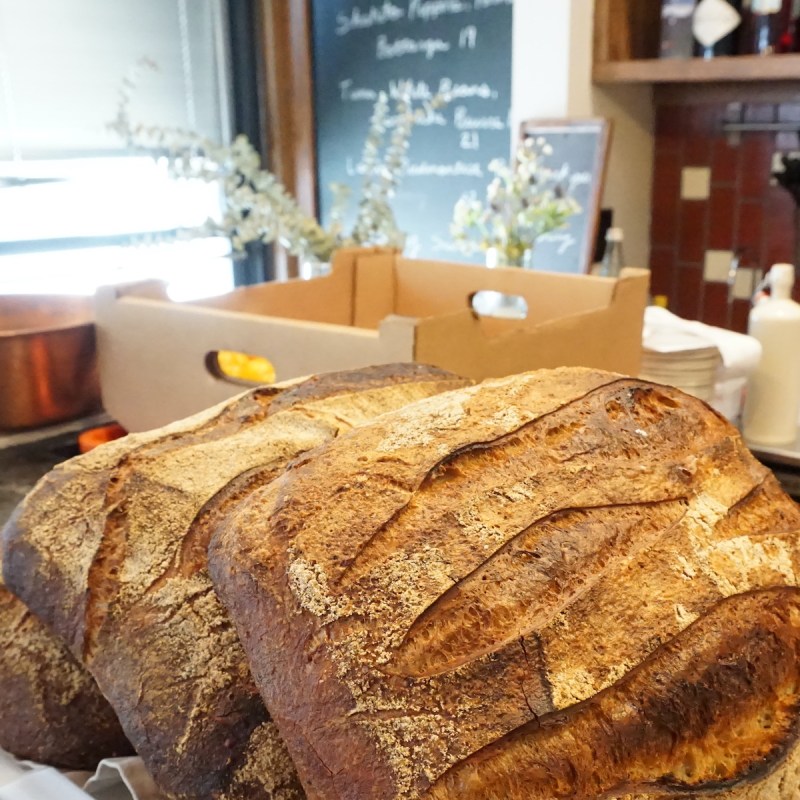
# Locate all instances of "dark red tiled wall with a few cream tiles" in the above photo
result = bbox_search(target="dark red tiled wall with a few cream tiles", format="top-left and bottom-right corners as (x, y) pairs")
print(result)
(651, 103), (800, 331)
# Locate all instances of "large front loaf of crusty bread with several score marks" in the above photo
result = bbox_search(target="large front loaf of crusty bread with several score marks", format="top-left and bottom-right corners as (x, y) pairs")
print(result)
(209, 369), (800, 800)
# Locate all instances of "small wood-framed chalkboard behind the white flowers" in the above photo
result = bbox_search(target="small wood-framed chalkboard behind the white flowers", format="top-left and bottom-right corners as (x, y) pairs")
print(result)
(520, 119), (611, 273)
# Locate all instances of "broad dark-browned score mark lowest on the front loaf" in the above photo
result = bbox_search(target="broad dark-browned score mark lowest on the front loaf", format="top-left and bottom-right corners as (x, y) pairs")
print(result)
(424, 587), (800, 800)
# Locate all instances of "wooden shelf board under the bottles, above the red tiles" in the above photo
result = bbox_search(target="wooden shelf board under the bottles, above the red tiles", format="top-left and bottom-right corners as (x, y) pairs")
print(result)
(593, 54), (800, 84)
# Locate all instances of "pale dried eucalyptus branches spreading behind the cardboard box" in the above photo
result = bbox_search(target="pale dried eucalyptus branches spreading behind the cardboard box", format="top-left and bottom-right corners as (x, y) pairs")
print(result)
(109, 60), (447, 261)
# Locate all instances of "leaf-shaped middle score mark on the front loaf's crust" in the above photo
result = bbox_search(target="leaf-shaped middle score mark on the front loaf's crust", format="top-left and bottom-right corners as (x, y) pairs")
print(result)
(386, 497), (687, 677)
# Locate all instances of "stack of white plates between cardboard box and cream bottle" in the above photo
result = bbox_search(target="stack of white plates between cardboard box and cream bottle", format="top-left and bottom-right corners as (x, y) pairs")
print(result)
(639, 328), (722, 402)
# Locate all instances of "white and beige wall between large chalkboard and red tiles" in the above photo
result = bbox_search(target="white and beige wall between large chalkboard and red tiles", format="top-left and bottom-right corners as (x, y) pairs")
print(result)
(511, 0), (654, 266)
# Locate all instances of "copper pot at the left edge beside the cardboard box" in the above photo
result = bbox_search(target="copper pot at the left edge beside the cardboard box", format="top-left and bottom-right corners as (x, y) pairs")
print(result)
(0, 295), (100, 431)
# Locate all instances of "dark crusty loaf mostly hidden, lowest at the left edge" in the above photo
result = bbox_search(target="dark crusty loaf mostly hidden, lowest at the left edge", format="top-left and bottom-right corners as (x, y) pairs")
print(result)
(0, 544), (133, 769)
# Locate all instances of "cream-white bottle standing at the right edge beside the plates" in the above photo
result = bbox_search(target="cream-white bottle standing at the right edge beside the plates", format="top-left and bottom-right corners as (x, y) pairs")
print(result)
(743, 264), (800, 446)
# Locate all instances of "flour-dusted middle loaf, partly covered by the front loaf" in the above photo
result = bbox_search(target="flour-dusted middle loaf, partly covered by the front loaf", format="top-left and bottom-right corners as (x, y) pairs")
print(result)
(5, 365), (465, 800)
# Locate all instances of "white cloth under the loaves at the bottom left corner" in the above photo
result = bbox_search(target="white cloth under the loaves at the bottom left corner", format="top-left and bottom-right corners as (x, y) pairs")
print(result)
(0, 750), (163, 800)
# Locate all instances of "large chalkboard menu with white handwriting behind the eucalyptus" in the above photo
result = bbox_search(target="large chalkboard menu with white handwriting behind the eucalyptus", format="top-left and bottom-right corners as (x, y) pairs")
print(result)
(312, 0), (512, 260)
